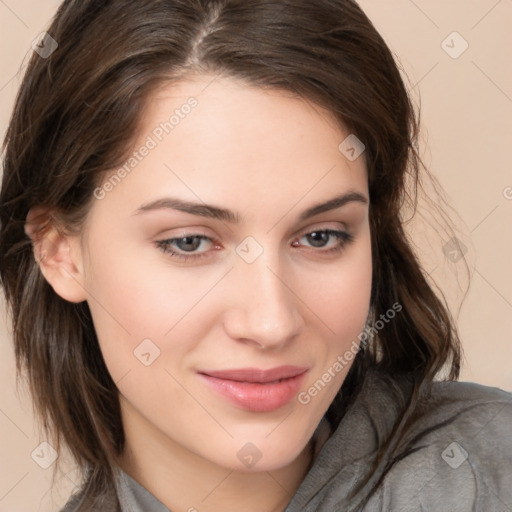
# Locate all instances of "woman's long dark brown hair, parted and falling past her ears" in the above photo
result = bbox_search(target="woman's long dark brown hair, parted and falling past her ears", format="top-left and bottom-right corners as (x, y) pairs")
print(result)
(0, 0), (460, 510)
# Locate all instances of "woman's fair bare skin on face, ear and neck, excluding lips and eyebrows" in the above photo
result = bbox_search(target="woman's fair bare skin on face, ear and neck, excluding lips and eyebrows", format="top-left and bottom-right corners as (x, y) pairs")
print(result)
(27, 75), (372, 512)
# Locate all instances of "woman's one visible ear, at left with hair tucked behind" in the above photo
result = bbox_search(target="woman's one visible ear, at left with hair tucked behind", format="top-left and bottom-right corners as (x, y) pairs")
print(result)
(25, 206), (87, 303)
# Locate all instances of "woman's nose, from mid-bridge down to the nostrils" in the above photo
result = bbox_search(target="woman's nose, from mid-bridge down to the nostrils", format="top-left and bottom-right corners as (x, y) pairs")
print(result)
(224, 252), (303, 349)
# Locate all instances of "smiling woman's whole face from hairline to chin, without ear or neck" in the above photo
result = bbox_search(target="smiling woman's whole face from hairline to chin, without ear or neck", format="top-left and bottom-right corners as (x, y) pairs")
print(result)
(77, 72), (372, 470)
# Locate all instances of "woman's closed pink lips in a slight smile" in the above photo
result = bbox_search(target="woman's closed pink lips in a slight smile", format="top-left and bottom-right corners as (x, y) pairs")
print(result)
(199, 366), (308, 412)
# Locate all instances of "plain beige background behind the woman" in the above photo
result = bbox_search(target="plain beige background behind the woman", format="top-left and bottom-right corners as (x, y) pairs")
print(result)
(0, 0), (512, 512)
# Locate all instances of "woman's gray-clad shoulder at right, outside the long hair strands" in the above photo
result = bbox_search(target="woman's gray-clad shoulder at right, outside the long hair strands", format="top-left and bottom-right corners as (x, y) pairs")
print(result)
(368, 382), (512, 512)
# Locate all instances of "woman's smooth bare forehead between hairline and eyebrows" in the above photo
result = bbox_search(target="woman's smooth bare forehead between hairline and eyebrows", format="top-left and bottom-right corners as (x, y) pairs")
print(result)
(90, 75), (367, 222)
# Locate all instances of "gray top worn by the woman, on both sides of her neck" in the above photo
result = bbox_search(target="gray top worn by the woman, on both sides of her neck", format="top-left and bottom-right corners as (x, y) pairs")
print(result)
(61, 371), (512, 512)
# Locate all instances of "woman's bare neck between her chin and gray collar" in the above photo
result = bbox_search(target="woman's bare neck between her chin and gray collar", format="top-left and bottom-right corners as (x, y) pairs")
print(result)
(119, 412), (318, 512)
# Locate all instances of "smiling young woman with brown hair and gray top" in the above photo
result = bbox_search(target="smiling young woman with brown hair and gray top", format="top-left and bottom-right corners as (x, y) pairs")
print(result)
(0, 0), (512, 512)
